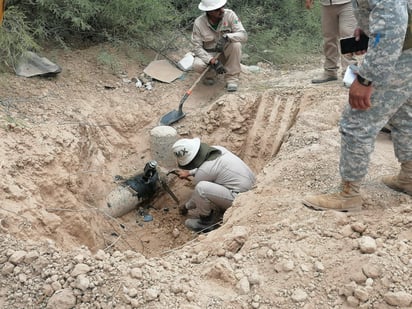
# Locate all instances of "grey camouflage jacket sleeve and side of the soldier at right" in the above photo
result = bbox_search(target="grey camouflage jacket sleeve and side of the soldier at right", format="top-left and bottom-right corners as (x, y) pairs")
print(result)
(352, 0), (412, 82)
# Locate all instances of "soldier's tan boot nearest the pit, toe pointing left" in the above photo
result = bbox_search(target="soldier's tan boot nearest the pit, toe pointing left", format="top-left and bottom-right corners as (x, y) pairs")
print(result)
(302, 181), (362, 212)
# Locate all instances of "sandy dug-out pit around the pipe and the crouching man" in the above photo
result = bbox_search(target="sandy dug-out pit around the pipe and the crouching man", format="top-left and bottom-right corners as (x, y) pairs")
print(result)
(0, 46), (304, 256)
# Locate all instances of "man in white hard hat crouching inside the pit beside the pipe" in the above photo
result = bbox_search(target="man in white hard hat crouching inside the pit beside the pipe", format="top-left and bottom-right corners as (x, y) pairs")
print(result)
(172, 138), (255, 232)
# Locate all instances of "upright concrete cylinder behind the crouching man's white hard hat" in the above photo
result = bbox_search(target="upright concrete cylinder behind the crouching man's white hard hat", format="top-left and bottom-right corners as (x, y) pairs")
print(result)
(150, 126), (177, 169)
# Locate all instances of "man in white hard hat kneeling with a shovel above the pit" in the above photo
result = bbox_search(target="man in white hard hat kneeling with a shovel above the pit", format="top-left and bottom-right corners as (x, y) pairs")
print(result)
(192, 0), (247, 91)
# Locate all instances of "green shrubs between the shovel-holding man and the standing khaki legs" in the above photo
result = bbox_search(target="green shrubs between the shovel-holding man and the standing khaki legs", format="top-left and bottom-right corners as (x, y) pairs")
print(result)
(230, 0), (322, 64)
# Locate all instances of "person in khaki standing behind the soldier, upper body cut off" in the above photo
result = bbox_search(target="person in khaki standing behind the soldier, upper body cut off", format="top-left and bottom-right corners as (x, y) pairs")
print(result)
(306, 0), (356, 84)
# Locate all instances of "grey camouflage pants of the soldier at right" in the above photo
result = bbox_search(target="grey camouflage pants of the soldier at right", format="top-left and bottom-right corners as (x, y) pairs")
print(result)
(339, 50), (412, 181)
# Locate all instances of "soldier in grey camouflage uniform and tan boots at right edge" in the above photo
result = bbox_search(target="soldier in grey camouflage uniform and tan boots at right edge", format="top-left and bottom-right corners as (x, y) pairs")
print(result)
(303, 0), (412, 211)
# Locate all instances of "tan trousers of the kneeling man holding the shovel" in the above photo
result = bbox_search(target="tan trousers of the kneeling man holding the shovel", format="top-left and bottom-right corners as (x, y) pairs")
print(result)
(193, 42), (242, 83)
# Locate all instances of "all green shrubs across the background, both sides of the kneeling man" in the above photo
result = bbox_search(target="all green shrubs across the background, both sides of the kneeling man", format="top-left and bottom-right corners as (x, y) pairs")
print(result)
(0, 0), (322, 65)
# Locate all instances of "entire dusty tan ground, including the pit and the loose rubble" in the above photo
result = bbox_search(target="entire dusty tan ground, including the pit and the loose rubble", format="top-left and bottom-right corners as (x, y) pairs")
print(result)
(0, 47), (412, 309)
